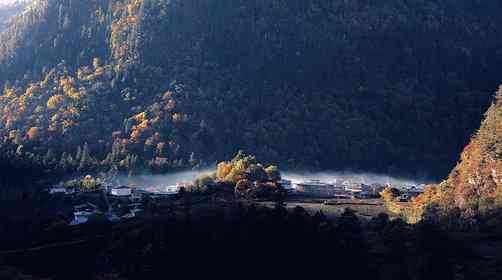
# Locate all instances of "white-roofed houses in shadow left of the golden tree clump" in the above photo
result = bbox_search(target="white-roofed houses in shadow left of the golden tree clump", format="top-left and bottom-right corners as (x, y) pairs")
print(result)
(48, 184), (182, 225)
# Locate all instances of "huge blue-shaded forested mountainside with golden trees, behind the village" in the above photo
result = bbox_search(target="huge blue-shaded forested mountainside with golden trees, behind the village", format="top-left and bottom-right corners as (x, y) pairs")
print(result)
(0, 0), (502, 176)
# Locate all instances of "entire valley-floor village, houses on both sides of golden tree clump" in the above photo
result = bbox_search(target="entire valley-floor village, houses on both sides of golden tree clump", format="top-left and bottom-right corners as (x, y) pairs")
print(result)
(48, 176), (425, 226)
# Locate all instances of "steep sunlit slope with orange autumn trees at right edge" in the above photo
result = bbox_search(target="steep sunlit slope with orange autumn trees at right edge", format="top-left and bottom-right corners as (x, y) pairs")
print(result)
(414, 87), (502, 219)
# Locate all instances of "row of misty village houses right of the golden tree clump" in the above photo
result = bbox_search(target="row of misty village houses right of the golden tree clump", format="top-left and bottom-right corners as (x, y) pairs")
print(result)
(280, 180), (424, 201)
